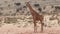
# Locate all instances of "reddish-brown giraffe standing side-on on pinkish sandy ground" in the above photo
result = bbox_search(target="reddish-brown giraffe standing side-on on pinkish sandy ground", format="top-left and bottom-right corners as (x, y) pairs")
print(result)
(26, 2), (44, 32)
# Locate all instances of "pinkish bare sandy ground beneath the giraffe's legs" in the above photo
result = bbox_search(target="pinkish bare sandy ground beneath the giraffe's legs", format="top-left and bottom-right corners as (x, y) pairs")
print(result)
(0, 24), (60, 34)
